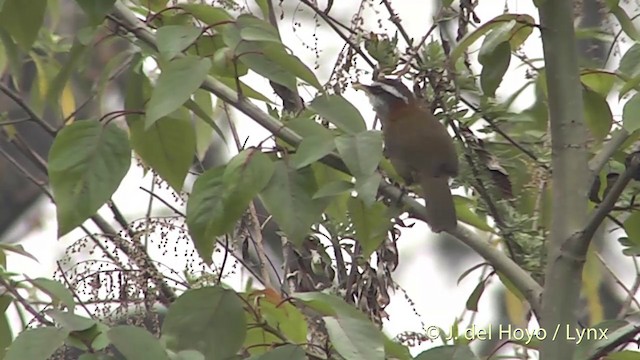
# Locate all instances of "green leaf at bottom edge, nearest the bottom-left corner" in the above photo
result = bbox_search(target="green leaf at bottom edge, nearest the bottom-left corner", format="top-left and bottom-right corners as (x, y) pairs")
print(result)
(4, 327), (69, 360)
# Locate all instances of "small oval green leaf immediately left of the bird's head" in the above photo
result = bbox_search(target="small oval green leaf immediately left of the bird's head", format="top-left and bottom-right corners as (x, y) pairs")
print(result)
(309, 95), (367, 134)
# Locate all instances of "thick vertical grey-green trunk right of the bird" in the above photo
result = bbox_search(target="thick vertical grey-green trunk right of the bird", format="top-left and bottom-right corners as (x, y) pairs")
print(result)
(538, 0), (591, 360)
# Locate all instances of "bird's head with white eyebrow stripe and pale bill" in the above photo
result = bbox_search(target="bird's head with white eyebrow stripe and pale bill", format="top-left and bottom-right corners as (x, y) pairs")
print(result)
(353, 78), (415, 120)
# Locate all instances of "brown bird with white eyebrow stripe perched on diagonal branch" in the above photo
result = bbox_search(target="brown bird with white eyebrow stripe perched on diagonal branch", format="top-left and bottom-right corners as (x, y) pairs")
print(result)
(353, 78), (458, 233)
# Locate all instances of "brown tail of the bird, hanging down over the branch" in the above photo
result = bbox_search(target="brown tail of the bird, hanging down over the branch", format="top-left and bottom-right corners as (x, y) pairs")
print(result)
(420, 176), (458, 233)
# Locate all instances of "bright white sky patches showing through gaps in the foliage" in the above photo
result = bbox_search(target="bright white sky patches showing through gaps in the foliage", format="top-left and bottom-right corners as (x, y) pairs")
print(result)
(2, 0), (633, 354)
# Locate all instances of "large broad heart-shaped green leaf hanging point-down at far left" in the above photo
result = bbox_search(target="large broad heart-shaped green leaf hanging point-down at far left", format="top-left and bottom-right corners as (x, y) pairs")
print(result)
(48, 120), (131, 236)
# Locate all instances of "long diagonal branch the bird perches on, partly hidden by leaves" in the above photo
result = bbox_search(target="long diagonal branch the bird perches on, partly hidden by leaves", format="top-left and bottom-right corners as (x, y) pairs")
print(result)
(115, 0), (542, 313)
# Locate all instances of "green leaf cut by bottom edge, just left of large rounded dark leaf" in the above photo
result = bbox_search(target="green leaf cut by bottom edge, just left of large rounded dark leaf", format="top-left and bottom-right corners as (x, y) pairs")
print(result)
(108, 325), (169, 360)
